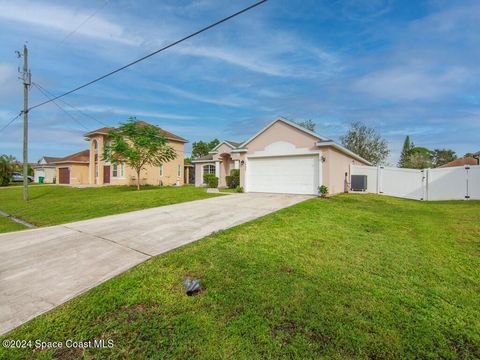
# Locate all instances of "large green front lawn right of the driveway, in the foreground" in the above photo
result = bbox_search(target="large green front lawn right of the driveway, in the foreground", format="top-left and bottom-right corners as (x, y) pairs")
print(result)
(0, 195), (480, 359)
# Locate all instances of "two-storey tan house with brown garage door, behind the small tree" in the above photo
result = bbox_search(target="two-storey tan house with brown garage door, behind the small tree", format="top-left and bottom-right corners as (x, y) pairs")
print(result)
(55, 121), (187, 185)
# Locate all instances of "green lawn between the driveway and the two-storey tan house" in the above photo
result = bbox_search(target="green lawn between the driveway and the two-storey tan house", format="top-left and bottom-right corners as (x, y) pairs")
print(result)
(0, 186), (218, 226)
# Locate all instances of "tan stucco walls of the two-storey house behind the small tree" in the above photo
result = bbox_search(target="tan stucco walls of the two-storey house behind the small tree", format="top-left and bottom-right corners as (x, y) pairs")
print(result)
(87, 135), (185, 185)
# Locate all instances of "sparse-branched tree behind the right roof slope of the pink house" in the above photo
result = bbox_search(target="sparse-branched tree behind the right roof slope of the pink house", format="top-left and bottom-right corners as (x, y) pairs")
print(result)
(340, 121), (390, 165)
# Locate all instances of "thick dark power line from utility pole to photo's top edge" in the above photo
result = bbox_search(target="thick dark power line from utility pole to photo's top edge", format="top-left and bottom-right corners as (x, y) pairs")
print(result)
(28, 0), (267, 111)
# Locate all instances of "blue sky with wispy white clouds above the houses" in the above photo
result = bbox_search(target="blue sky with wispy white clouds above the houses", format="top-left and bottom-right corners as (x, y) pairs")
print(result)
(0, 0), (480, 164)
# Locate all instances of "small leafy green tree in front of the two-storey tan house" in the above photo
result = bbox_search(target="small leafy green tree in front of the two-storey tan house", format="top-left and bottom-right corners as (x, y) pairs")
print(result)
(103, 118), (177, 190)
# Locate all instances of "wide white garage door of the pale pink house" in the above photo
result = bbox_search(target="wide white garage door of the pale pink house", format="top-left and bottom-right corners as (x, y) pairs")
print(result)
(246, 155), (319, 194)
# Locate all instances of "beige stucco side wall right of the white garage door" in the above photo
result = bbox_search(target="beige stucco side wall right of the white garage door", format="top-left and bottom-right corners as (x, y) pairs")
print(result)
(322, 147), (367, 194)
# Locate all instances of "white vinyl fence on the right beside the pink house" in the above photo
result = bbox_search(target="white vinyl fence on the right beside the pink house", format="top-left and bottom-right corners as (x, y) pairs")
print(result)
(350, 165), (480, 200)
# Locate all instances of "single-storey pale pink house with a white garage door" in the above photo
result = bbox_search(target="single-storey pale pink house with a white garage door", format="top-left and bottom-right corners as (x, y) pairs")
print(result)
(192, 118), (371, 194)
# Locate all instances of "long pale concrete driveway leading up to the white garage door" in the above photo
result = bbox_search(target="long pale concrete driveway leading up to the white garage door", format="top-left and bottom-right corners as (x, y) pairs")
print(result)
(0, 194), (310, 334)
